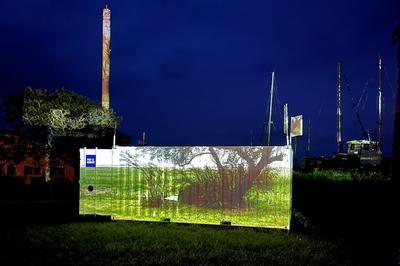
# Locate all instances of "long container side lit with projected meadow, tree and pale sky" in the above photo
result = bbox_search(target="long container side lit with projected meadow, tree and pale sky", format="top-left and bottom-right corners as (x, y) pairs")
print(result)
(80, 147), (291, 228)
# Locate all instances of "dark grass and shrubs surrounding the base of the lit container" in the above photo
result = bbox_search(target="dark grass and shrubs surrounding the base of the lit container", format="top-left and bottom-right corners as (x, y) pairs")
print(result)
(0, 170), (400, 265)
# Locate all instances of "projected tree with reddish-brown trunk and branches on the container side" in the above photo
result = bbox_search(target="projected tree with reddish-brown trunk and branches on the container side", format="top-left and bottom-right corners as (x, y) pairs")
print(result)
(122, 147), (283, 209)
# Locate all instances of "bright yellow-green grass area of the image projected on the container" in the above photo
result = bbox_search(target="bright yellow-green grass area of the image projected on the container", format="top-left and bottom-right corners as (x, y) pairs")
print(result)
(80, 167), (291, 228)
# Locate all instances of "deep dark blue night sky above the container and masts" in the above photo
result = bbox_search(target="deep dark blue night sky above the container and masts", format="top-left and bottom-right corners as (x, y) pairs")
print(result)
(0, 0), (400, 155)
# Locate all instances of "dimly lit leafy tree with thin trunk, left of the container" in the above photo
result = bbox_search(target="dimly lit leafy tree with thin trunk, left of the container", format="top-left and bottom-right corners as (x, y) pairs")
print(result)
(23, 87), (120, 181)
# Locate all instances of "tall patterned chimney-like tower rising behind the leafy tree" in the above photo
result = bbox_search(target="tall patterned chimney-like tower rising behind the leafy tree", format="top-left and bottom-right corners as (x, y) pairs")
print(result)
(101, 6), (111, 110)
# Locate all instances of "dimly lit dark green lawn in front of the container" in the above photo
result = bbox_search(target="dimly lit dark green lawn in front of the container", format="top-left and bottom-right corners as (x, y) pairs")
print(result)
(0, 221), (352, 265)
